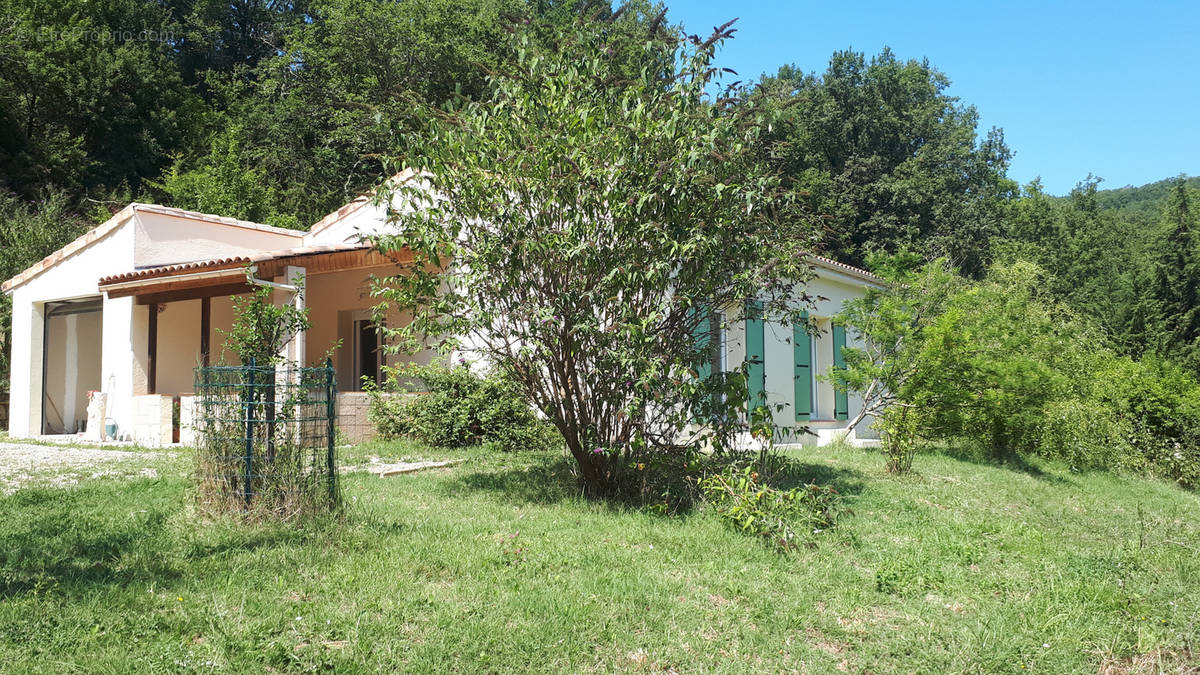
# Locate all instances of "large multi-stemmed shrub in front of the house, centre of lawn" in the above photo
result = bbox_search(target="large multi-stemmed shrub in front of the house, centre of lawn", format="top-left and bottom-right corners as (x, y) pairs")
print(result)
(378, 26), (810, 496)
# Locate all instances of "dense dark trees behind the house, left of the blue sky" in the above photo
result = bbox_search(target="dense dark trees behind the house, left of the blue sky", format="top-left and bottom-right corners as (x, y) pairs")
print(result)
(0, 0), (661, 224)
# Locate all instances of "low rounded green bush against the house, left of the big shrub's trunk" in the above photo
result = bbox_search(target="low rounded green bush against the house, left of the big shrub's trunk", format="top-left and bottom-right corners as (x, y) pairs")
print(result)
(367, 363), (558, 452)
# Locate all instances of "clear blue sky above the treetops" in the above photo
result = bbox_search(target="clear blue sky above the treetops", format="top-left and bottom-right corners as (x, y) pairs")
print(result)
(667, 0), (1200, 195)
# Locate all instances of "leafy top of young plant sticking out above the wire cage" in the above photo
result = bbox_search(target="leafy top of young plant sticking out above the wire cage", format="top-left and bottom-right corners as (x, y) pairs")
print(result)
(217, 270), (312, 365)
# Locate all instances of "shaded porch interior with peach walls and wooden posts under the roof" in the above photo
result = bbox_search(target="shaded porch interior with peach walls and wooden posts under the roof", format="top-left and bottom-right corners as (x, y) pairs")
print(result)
(94, 249), (432, 442)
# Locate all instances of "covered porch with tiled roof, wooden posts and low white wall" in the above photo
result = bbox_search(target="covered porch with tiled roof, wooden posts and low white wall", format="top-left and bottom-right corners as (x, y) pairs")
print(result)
(90, 244), (432, 446)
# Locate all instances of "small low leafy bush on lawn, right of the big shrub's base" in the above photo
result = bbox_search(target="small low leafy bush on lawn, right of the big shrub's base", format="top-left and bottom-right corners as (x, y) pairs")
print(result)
(700, 466), (840, 549)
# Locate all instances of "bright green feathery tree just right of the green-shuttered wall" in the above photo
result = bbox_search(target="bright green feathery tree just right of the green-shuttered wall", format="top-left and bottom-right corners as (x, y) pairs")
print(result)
(839, 255), (1115, 459)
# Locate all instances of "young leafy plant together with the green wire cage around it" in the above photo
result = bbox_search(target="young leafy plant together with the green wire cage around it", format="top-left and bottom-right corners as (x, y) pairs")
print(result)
(196, 270), (341, 520)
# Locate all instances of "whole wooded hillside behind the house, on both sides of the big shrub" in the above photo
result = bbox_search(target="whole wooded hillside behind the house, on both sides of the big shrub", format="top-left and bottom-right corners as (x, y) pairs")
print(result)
(0, 0), (1200, 468)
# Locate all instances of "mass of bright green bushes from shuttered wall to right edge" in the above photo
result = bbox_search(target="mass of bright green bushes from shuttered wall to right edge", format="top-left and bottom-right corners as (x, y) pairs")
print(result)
(841, 253), (1200, 486)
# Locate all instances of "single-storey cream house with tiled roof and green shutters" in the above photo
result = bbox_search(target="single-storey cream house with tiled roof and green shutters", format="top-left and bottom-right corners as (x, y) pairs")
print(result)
(0, 176), (878, 446)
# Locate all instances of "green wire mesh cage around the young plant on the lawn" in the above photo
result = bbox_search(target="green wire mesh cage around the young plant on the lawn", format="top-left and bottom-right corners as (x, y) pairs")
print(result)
(193, 359), (341, 519)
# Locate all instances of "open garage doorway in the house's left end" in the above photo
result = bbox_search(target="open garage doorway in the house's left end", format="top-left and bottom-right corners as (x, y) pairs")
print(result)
(42, 295), (103, 434)
